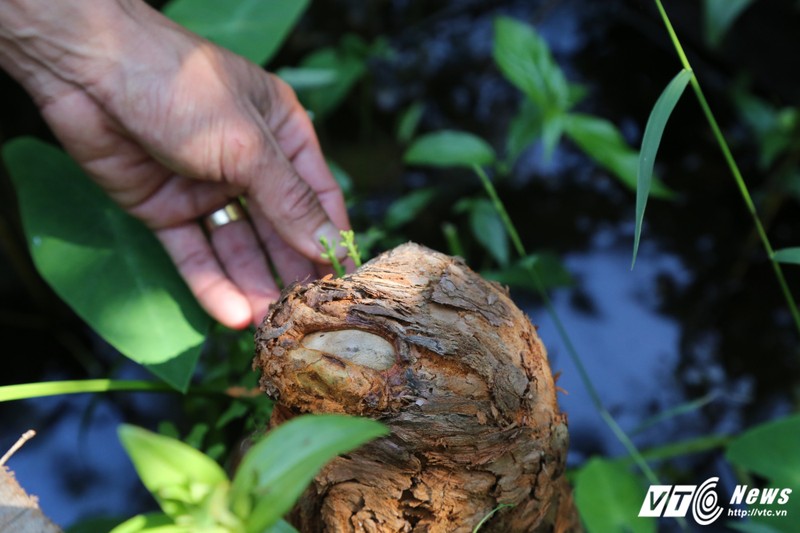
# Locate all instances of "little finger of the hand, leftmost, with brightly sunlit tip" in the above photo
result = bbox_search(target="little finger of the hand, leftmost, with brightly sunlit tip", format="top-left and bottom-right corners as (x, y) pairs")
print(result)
(156, 224), (253, 329)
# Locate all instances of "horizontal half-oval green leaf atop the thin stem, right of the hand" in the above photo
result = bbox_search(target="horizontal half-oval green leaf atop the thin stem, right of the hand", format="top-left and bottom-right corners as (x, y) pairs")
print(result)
(403, 130), (495, 167)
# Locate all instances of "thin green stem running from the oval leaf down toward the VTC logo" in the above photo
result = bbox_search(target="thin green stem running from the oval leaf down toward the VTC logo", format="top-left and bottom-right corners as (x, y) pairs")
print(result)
(473, 165), (659, 485)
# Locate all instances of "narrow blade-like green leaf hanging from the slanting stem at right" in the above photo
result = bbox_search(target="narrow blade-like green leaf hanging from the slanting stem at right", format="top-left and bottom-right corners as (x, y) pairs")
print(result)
(631, 69), (693, 268)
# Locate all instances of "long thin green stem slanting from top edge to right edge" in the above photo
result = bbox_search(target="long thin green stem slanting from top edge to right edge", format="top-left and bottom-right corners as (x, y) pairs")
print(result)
(655, 0), (800, 332)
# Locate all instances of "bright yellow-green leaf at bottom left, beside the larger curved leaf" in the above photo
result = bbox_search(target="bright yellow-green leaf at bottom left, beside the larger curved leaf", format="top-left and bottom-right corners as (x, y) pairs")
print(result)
(117, 424), (228, 518)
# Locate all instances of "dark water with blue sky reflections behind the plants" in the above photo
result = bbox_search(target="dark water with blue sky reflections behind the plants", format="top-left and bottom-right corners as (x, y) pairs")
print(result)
(0, 0), (800, 527)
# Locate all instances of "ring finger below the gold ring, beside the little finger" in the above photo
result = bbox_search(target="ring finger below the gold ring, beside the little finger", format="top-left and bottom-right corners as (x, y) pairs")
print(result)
(209, 212), (280, 325)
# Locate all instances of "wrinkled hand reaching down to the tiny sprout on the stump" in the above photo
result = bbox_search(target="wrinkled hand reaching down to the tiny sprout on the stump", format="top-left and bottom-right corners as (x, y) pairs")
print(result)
(0, 0), (349, 328)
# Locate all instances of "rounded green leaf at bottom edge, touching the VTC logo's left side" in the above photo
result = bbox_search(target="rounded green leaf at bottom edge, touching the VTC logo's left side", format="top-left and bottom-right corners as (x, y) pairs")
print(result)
(574, 458), (656, 533)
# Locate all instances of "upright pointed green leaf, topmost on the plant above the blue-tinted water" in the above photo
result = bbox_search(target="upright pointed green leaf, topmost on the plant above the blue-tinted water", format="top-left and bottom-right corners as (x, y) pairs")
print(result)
(492, 17), (574, 115)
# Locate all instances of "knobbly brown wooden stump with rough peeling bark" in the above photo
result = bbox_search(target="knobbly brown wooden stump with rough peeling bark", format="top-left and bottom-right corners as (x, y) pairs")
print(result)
(254, 244), (579, 533)
